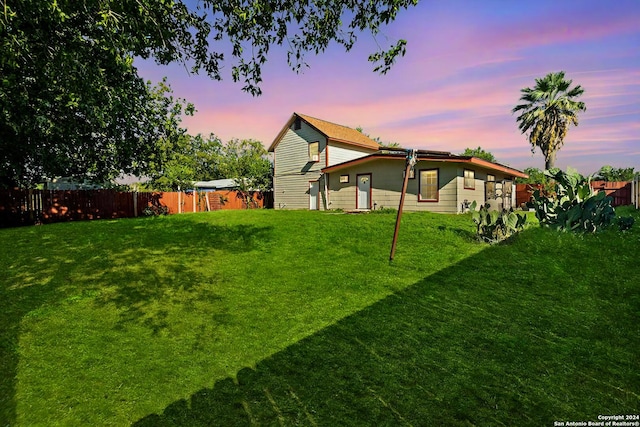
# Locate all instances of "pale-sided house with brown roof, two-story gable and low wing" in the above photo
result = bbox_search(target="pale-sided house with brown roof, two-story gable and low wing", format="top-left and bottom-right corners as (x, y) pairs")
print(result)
(269, 113), (527, 213)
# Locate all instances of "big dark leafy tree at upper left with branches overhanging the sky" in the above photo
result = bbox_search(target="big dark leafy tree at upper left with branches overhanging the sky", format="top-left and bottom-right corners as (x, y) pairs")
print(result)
(0, 0), (417, 186)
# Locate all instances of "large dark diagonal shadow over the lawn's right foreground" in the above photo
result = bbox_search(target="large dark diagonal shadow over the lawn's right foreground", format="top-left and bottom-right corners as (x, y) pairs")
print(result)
(134, 229), (640, 427)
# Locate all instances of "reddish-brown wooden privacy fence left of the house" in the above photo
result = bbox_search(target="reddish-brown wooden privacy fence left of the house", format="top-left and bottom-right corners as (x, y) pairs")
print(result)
(0, 189), (273, 227)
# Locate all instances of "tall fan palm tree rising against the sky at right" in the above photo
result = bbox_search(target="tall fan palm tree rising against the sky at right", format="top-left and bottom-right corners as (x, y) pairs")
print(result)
(511, 71), (586, 169)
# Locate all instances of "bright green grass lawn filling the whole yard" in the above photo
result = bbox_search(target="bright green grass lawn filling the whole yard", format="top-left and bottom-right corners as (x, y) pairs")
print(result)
(0, 210), (640, 427)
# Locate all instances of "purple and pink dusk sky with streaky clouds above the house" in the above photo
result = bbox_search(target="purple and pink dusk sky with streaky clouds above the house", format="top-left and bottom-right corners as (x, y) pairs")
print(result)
(136, 0), (640, 175)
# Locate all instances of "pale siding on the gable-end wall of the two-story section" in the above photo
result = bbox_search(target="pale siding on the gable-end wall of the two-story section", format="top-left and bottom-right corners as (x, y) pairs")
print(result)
(273, 121), (327, 209)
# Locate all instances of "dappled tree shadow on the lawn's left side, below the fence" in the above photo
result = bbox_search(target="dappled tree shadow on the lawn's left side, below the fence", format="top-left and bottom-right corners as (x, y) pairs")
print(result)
(0, 218), (271, 427)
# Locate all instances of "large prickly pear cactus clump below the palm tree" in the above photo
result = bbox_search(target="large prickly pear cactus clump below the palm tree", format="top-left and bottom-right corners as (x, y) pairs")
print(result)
(533, 169), (615, 232)
